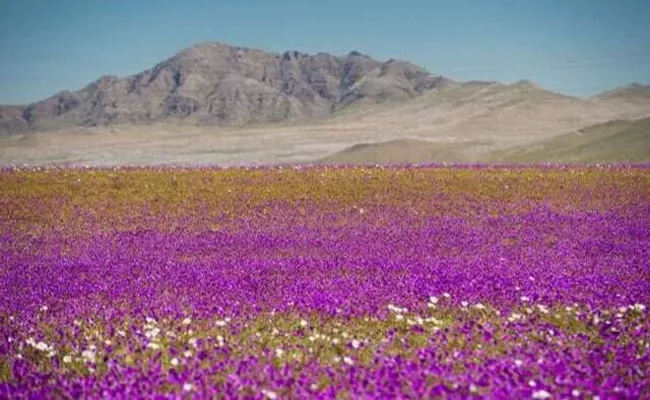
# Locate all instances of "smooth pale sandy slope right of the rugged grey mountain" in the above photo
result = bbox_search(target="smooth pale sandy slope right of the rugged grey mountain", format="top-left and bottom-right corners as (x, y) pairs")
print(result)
(322, 81), (650, 146)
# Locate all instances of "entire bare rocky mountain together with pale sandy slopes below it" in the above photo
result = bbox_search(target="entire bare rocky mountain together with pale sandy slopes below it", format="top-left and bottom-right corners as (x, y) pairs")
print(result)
(0, 43), (650, 165)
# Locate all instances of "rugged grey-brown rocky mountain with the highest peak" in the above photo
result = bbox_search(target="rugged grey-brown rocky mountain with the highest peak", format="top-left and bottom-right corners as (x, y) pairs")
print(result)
(0, 42), (448, 135)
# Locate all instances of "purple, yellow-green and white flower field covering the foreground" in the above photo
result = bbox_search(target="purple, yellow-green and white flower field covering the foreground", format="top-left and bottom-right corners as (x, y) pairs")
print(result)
(0, 166), (650, 399)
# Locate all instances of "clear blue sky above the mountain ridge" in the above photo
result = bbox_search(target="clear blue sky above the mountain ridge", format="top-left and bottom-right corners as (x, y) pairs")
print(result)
(0, 0), (650, 104)
